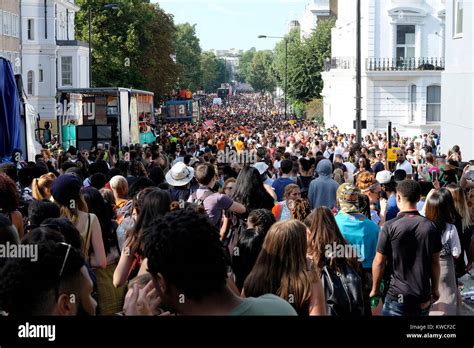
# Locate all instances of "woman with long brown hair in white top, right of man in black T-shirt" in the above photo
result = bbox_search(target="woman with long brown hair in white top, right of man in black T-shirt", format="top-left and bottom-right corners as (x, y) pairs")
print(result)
(425, 188), (461, 315)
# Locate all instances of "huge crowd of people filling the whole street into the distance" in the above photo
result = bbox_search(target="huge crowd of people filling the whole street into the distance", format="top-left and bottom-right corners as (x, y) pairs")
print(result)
(0, 94), (474, 316)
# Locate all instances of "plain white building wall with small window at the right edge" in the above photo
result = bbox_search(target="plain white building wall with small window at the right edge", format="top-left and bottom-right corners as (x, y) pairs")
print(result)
(441, 0), (474, 161)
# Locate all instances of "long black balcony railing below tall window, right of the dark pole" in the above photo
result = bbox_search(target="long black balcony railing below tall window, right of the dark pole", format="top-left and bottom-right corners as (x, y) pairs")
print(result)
(366, 57), (444, 71)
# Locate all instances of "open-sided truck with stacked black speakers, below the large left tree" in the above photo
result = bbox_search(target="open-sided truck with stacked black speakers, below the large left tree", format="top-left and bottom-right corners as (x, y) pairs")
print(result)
(56, 87), (157, 149)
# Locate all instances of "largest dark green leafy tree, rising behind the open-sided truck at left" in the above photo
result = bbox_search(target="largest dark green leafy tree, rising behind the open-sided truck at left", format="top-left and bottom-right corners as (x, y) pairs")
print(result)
(76, 0), (178, 102)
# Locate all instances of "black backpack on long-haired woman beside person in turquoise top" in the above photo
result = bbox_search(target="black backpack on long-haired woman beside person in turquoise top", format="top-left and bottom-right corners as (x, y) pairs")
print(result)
(321, 262), (364, 317)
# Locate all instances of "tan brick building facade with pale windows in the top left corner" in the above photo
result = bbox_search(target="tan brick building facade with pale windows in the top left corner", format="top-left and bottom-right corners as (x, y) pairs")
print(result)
(0, 0), (21, 74)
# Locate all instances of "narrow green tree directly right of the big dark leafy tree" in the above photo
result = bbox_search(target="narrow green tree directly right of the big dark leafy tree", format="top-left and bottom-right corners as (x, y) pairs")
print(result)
(174, 23), (202, 91)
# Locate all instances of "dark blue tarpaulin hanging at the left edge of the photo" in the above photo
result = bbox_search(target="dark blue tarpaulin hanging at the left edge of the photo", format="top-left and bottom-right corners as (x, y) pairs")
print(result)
(0, 57), (21, 162)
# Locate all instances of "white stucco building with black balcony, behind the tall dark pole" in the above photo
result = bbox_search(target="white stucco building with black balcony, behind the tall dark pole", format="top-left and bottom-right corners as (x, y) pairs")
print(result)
(322, 0), (445, 135)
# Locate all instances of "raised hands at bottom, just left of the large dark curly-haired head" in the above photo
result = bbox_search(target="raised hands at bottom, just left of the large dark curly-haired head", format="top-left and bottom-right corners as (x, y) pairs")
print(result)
(123, 281), (161, 316)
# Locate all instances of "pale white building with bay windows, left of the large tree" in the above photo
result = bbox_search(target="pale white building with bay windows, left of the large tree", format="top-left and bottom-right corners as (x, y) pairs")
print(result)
(21, 0), (89, 121)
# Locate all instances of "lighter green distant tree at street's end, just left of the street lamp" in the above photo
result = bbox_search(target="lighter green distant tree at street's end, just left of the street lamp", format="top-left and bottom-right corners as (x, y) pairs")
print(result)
(248, 51), (277, 92)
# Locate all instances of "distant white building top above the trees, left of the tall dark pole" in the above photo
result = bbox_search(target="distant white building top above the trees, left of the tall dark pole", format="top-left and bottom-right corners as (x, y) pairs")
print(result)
(300, 0), (337, 39)
